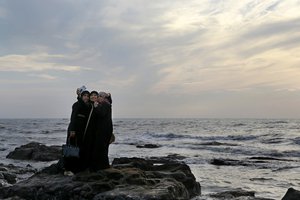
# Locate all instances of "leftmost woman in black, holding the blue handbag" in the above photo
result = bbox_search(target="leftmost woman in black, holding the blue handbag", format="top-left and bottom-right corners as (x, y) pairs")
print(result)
(65, 90), (92, 173)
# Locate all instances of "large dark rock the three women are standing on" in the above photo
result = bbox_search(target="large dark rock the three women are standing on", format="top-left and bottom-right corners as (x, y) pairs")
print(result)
(0, 158), (201, 200)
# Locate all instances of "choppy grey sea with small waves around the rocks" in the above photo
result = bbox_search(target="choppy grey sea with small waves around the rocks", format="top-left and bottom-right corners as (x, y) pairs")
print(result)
(0, 119), (300, 199)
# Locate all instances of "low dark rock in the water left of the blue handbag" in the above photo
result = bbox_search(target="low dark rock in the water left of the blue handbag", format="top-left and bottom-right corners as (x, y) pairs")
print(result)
(6, 142), (61, 161)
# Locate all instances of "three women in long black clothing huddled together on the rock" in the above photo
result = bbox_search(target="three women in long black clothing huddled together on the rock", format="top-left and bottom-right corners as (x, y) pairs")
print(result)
(64, 86), (114, 173)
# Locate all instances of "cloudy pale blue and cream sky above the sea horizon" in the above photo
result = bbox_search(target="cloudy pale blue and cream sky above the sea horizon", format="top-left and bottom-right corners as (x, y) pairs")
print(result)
(0, 0), (300, 118)
